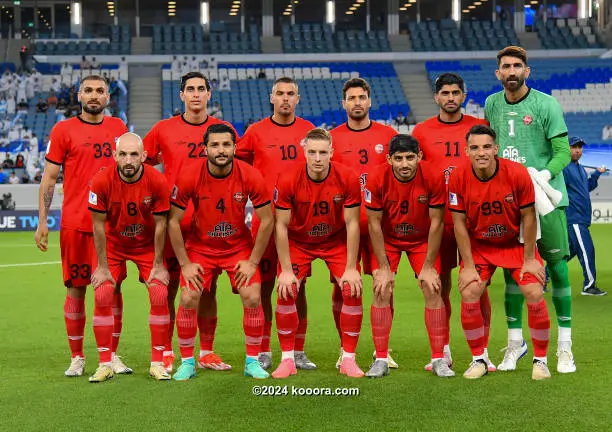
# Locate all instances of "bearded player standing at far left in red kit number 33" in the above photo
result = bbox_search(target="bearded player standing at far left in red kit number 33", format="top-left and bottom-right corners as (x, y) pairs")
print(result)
(34, 75), (131, 376)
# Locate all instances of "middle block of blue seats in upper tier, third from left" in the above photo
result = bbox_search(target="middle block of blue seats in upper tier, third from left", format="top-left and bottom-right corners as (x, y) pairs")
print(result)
(281, 23), (391, 53)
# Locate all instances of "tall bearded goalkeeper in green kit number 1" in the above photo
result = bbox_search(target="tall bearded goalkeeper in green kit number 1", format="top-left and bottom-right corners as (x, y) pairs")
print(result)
(485, 46), (576, 373)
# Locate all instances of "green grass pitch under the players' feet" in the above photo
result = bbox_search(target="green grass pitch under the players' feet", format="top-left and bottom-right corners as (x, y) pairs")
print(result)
(0, 225), (612, 431)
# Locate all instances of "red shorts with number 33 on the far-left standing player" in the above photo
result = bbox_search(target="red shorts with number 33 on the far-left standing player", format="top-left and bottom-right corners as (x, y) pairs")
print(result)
(60, 228), (98, 288)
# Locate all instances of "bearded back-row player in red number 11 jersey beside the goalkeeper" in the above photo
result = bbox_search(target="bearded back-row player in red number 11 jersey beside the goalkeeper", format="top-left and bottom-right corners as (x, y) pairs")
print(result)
(412, 73), (495, 372)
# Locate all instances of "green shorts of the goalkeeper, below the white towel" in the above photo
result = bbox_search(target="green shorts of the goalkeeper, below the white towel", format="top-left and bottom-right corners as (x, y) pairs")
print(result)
(538, 208), (569, 263)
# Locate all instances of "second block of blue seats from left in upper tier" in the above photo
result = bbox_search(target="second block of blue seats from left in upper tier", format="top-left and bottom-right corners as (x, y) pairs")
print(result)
(153, 24), (261, 54)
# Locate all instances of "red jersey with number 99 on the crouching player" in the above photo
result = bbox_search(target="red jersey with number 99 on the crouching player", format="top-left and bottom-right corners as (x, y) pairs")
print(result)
(448, 159), (535, 247)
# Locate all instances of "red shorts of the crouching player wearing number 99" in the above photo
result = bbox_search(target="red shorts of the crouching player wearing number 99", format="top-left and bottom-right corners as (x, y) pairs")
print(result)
(461, 242), (543, 286)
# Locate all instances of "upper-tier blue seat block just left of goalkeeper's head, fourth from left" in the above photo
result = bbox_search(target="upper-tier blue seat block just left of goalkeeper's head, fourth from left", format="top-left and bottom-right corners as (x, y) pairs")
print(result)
(408, 19), (518, 51)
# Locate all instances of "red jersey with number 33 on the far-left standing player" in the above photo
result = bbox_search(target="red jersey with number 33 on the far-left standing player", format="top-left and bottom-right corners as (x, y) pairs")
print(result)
(45, 116), (128, 232)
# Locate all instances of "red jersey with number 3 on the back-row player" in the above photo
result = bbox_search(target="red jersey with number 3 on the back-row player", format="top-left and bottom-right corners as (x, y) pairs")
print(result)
(331, 121), (397, 235)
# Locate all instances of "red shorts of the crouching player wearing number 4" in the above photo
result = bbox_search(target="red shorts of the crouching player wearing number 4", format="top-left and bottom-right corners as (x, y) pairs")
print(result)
(181, 248), (261, 294)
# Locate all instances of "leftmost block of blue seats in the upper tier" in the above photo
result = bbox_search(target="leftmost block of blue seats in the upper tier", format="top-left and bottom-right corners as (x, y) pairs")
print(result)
(34, 25), (132, 55)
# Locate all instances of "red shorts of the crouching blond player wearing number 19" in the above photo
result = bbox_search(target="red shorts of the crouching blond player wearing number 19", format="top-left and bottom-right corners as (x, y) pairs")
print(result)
(278, 240), (352, 282)
